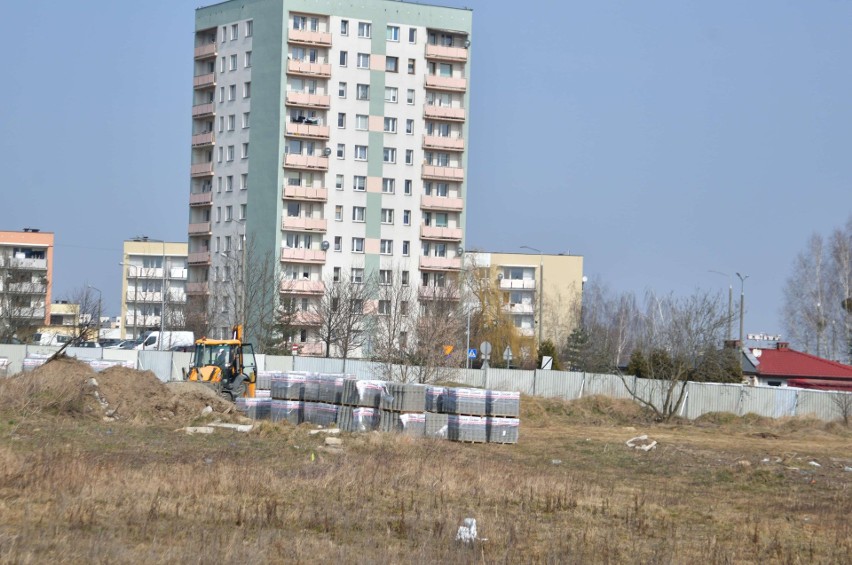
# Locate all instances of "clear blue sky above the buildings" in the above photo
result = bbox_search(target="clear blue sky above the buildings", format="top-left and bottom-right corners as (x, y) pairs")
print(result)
(0, 0), (852, 340)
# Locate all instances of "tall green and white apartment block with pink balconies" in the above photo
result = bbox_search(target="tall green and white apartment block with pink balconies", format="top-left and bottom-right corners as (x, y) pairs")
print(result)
(187, 0), (472, 346)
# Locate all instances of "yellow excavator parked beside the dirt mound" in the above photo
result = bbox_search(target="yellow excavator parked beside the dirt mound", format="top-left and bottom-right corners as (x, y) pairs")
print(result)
(184, 325), (257, 401)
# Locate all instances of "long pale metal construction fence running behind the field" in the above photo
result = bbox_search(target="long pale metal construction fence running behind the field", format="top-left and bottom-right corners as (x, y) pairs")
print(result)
(0, 345), (852, 421)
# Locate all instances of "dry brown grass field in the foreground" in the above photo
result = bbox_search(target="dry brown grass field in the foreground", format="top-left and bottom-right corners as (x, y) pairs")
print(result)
(0, 364), (852, 563)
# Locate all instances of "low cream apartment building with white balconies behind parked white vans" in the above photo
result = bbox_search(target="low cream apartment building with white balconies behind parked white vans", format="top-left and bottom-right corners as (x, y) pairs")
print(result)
(120, 239), (187, 339)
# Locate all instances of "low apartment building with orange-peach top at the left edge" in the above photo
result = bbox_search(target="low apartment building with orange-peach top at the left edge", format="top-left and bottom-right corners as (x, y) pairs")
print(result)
(0, 228), (53, 341)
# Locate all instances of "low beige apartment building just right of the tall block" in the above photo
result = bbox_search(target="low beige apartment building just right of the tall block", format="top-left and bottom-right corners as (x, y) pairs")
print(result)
(465, 252), (584, 343)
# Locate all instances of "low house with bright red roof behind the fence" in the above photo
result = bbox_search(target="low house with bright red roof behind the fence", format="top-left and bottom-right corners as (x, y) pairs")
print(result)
(742, 342), (852, 392)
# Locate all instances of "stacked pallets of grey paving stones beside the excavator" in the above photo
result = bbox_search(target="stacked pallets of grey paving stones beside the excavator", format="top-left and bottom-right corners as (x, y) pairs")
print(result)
(237, 371), (520, 443)
